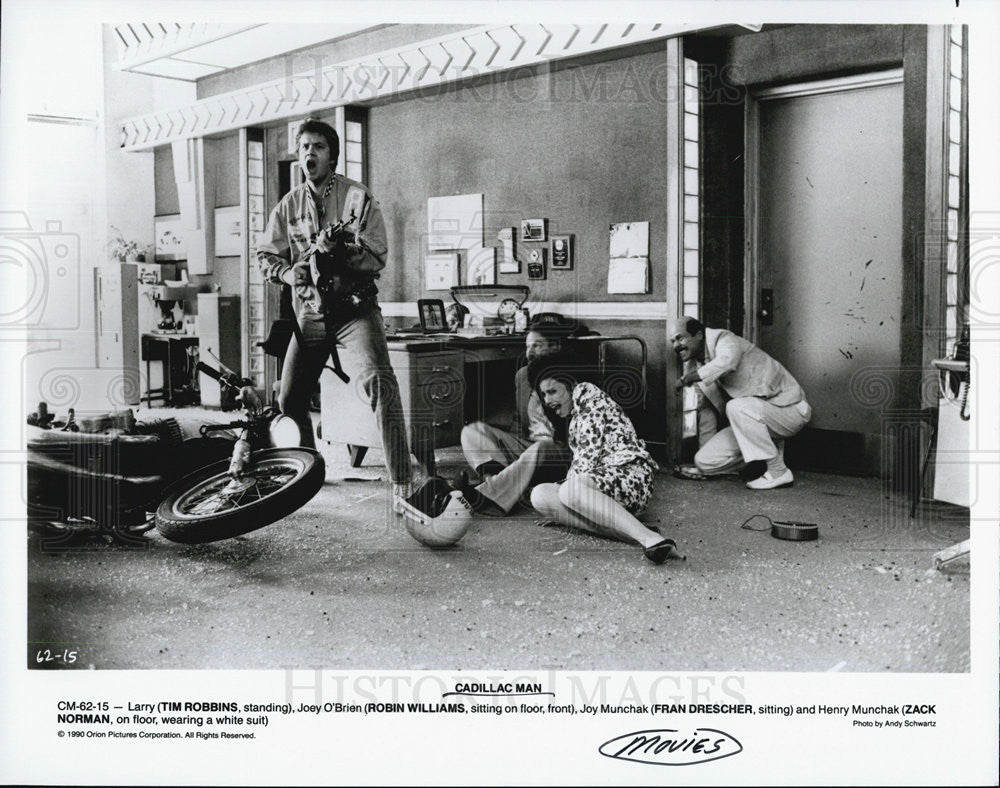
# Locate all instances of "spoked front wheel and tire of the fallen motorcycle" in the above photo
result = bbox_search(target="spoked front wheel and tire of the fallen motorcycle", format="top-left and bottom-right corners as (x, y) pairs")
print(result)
(156, 448), (326, 544)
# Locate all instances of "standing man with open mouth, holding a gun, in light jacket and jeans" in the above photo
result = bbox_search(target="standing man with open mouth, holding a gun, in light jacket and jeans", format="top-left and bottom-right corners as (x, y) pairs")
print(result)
(257, 118), (411, 505)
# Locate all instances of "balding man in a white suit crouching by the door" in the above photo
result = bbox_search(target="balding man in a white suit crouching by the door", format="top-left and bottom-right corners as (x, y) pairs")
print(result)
(669, 317), (812, 490)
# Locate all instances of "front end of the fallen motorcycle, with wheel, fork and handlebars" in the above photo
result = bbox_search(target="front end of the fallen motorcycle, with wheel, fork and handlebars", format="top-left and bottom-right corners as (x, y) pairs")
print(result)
(155, 362), (326, 544)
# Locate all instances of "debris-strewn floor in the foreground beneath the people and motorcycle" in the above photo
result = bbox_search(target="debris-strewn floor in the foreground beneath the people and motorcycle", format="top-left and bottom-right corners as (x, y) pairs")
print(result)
(28, 438), (969, 672)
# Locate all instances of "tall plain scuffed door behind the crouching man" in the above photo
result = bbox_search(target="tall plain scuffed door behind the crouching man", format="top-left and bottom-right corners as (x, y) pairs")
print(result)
(756, 82), (903, 473)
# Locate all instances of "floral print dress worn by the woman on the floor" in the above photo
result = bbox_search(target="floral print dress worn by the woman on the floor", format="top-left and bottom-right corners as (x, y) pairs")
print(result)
(567, 383), (658, 473)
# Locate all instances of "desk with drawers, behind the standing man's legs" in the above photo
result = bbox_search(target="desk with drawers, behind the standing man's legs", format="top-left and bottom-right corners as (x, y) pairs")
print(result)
(320, 334), (524, 475)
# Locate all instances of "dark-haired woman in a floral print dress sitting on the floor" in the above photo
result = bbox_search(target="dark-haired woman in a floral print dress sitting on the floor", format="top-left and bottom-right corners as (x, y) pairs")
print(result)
(528, 354), (676, 564)
